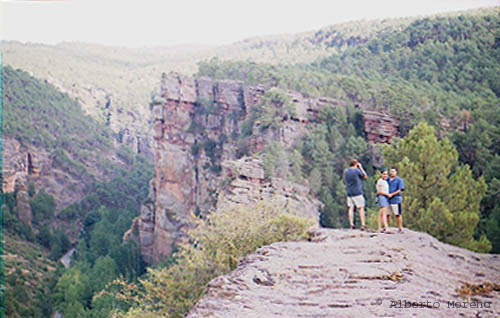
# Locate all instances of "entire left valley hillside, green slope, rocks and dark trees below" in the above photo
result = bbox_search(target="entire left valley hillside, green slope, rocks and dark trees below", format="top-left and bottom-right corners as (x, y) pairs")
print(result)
(1, 66), (153, 317)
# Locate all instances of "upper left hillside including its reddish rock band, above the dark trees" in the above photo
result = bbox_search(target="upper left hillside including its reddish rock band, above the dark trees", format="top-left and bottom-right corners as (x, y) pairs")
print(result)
(3, 66), (137, 211)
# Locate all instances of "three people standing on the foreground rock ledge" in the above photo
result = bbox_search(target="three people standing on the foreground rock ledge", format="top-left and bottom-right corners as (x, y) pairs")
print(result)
(344, 159), (404, 233)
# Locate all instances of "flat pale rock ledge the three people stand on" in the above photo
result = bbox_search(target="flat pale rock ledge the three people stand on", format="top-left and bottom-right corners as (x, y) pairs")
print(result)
(186, 229), (500, 318)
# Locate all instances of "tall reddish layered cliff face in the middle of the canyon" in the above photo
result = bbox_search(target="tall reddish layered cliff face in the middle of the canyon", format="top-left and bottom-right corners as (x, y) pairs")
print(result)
(130, 73), (402, 263)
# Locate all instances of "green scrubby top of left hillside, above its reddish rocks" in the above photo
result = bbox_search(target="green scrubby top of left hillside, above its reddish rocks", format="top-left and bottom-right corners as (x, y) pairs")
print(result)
(3, 66), (113, 163)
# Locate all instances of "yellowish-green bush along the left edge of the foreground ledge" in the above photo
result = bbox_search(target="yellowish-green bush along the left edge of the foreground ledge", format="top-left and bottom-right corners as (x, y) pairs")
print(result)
(108, 198), (312, 318)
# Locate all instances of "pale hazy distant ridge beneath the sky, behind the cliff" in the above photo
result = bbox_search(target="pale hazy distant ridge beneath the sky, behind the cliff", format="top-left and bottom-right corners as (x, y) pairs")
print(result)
(2, 8), (498, 155)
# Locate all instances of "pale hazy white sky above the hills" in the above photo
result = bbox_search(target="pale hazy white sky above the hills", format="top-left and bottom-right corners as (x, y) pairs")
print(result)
(0, 0), (500, 47)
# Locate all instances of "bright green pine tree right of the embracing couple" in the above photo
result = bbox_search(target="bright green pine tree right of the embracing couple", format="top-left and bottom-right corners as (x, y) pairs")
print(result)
(384, 123), (491, 252)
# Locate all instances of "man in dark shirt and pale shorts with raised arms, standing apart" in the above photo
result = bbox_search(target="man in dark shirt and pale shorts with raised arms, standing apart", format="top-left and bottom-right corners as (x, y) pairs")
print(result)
(344, 159), (367, 231)
